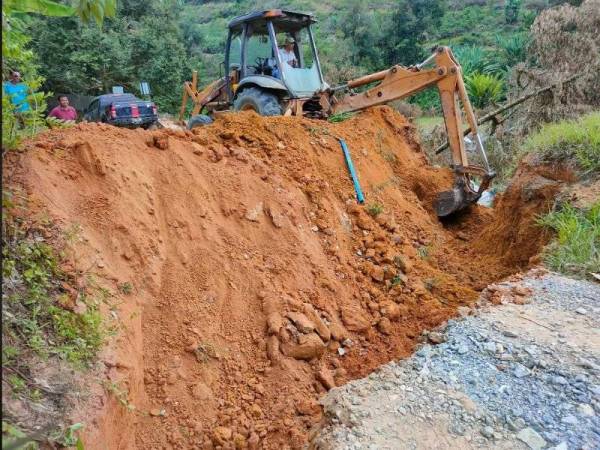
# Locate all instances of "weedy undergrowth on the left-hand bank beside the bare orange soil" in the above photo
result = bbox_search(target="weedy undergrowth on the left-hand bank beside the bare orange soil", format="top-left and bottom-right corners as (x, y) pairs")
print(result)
(2, 189), (109, 448)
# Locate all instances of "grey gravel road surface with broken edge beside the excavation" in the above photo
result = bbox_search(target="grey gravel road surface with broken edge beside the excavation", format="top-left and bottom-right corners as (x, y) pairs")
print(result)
(313, 273), (600, 449)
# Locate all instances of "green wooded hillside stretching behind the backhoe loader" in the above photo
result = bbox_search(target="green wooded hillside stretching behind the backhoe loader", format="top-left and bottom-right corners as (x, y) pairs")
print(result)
(21, 0), (559, 112)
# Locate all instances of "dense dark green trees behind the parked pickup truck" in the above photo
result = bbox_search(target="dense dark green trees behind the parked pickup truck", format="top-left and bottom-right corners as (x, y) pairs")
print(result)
(30, 0), (192, 112)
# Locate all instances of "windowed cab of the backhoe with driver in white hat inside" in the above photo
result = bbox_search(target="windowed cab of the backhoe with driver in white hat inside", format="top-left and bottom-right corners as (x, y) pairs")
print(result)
(225, 9), (327, 102)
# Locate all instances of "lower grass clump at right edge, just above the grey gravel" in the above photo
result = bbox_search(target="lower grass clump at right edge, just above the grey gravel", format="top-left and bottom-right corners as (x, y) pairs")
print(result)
(538, 201), (600, 278)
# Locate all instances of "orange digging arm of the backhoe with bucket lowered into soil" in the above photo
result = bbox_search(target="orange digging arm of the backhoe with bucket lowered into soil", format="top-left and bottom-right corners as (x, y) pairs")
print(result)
(330, 47), (495, 217)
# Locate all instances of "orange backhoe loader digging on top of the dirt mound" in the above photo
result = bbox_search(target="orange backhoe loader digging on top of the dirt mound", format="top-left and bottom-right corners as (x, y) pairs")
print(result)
(179, 9), (495, 217)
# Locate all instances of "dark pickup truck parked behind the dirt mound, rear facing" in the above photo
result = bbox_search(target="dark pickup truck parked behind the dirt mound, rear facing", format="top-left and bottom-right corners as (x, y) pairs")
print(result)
(83, 94), (158, 128)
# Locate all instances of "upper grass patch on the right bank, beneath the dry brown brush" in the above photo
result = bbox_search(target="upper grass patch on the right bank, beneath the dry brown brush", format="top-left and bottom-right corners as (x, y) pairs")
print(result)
(520, 112), (600, 174)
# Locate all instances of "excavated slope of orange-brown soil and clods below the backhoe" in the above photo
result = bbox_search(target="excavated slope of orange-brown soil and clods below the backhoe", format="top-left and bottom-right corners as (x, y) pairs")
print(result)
(9, 107), (564, 449)
